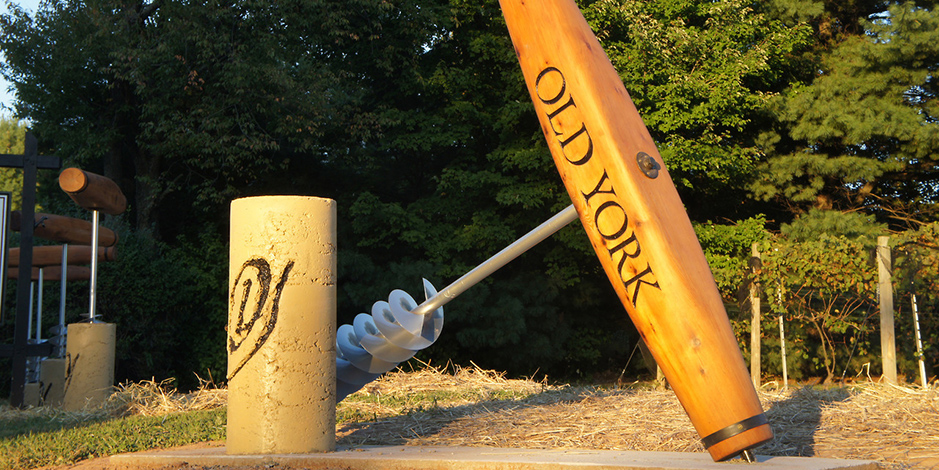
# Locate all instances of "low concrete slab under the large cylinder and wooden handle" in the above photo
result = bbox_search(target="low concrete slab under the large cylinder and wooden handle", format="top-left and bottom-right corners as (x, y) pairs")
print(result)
(109, 446), (880, 470)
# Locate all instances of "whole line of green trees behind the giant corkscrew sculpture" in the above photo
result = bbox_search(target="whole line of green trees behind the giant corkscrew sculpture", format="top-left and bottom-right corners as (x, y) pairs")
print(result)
(0, 0), (939, 390)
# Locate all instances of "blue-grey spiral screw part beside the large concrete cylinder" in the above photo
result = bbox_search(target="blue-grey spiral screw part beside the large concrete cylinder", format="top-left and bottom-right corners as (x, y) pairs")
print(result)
(336, 279), (443, 403)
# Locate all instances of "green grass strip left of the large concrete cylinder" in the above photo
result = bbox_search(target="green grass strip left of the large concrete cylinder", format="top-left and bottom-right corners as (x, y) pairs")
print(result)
(0, 407), (225, 470)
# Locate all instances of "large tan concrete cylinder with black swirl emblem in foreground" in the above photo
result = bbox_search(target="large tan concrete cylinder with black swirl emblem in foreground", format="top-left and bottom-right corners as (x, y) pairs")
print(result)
(227, 196), (336, 454)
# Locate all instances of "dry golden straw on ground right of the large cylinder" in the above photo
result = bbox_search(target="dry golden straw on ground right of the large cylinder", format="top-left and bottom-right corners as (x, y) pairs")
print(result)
(337, 370), (939, 468)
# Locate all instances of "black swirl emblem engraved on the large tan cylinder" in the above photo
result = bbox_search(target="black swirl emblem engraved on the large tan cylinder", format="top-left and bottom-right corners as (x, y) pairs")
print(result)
(228, 257), (294, 380)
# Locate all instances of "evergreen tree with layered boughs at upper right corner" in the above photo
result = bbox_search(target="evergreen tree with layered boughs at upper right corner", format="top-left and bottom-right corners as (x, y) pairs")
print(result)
(751, 3), (939, 226)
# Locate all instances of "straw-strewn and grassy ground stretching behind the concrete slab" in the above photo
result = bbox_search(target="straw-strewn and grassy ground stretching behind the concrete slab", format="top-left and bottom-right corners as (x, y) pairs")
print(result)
(0, 367), (939, 470)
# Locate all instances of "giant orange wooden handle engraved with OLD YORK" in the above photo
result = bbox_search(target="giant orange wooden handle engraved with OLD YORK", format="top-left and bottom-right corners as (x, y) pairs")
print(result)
(500, 0), (773, 460)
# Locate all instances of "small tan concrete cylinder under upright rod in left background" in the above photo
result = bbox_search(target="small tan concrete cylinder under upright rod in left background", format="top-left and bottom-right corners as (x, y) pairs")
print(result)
(62, 323), (117, 411)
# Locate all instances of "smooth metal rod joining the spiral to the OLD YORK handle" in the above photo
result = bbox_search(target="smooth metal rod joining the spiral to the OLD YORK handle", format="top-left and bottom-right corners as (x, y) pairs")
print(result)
(411, 204), (577, 315)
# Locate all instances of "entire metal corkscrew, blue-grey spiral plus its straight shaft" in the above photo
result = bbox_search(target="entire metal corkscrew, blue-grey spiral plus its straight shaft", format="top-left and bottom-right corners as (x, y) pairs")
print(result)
(336, 205), (577, 403)
